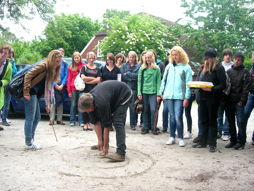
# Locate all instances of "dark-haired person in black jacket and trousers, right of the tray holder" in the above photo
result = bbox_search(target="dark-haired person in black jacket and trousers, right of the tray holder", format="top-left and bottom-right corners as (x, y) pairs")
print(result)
(225, 53), (250, 150)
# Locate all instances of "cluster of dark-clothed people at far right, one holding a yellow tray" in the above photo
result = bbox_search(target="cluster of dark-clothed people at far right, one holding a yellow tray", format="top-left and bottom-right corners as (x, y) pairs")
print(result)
(193, 49), (254, 152)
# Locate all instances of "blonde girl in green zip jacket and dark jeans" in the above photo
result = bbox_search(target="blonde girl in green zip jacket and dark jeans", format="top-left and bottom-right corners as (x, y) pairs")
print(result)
(138, 51), (161, 134)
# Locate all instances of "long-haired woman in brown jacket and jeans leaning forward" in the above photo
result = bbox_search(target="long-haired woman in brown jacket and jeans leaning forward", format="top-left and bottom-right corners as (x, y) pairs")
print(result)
(23, 50), (62, 150)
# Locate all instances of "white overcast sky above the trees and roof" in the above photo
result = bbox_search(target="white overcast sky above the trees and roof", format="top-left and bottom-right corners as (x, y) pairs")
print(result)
(5, 0), (187, 40)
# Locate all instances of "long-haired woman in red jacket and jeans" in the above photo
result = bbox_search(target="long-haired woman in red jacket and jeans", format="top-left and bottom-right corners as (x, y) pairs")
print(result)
(67, 52), (85, 127)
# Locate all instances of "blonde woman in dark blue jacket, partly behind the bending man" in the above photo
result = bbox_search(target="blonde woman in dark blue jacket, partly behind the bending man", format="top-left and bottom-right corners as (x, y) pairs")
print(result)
(120, 51), (140, 130)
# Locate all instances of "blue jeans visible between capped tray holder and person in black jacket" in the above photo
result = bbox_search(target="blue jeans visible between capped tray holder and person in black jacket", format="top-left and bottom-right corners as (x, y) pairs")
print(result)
(217, 103), (229, 135)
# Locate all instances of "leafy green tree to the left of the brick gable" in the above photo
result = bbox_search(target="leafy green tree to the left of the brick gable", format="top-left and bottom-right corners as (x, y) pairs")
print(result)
(41, 14), (100, 56)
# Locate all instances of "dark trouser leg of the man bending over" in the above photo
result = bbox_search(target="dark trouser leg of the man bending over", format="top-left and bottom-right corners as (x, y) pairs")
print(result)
(113, 102), (129, 155)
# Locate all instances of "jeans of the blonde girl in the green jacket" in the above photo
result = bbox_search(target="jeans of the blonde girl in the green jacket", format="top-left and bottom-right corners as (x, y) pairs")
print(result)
(142, 94), (157, 130)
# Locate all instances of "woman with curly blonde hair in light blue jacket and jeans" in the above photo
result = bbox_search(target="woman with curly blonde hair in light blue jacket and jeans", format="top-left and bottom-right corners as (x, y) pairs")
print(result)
(160, 46), (192, 147)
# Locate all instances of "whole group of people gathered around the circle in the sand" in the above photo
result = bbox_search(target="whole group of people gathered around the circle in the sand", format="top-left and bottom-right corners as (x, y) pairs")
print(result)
(0, 46), (254, 161)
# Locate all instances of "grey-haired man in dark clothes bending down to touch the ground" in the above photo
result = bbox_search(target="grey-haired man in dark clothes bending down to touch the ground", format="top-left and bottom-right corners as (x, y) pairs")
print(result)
(78, 80), (132, 162)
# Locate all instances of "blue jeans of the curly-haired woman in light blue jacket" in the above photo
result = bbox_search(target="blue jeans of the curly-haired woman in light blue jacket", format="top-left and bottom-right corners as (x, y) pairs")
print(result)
(166, 99), (183, 139)
